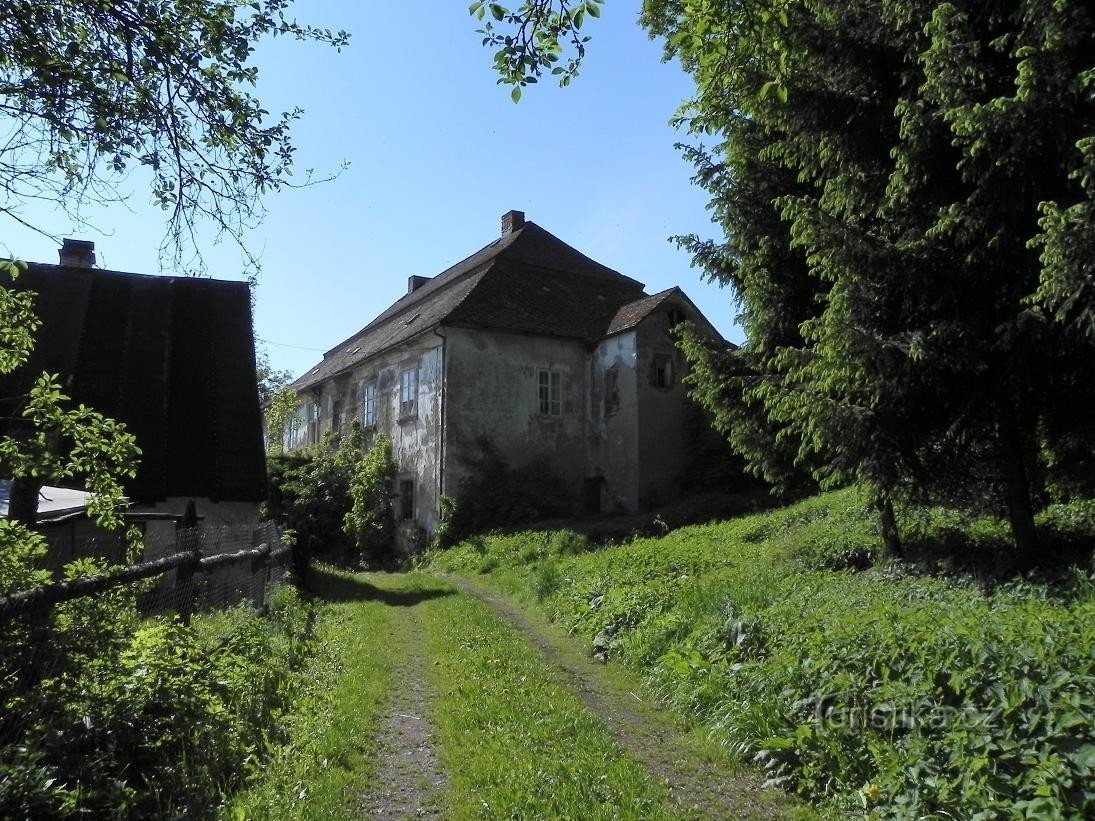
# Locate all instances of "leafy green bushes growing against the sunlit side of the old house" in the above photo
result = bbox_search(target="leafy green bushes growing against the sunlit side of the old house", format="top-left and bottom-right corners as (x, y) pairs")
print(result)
(264, 421), (395, 566)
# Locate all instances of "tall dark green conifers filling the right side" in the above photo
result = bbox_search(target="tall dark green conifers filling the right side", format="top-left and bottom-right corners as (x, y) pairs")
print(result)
(483, 0), (1095, 555)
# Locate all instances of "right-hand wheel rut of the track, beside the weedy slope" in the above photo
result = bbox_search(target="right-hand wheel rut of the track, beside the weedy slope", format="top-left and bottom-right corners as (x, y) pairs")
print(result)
(445, 576), (787, 819)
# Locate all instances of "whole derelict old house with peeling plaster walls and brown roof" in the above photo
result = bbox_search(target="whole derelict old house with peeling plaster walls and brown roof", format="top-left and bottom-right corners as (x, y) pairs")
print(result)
(285, 211), (717, 551)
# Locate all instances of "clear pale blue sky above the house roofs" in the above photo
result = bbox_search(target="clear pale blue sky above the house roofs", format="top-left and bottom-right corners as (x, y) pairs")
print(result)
(0, 0), (741, 374)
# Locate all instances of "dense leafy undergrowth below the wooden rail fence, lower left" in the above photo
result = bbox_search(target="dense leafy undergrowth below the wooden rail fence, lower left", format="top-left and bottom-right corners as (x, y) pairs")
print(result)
(0, 569), (314, 818)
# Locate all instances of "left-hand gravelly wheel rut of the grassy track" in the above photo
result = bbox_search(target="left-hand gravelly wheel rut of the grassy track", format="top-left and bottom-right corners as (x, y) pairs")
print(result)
(361, 606), (446, 819)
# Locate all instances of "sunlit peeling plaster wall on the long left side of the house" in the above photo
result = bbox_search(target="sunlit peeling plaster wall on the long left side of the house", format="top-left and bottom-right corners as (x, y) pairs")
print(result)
(302, 333), (443, 553)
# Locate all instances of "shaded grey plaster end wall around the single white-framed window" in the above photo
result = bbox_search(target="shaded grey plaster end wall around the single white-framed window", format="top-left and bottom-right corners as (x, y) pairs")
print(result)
(445, 328), (589, 509)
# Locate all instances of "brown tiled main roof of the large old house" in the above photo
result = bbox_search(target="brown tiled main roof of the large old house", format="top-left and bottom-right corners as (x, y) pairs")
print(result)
(292, 222), (645, 391)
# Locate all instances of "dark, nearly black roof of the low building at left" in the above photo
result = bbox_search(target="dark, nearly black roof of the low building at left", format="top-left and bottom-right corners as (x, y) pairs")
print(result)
(0, 264), (266, 501)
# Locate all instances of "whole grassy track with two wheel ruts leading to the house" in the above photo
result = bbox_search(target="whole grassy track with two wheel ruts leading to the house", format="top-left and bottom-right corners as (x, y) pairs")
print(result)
(226, 573), (801, 819)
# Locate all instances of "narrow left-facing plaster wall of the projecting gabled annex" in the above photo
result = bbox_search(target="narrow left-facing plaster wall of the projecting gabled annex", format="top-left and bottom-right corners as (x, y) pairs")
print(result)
(588, 332), (639, 512)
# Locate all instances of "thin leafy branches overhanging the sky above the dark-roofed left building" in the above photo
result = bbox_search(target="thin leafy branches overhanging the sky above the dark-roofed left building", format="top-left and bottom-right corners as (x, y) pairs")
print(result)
(0, 0), (348, 270)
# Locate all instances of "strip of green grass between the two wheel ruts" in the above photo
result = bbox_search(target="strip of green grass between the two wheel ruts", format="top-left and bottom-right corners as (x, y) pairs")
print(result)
(423, 582), (680, 819)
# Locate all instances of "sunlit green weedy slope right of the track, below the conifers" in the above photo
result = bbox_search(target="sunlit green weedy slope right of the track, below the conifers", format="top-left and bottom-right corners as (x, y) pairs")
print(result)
(431, 490), (1095, 817)
